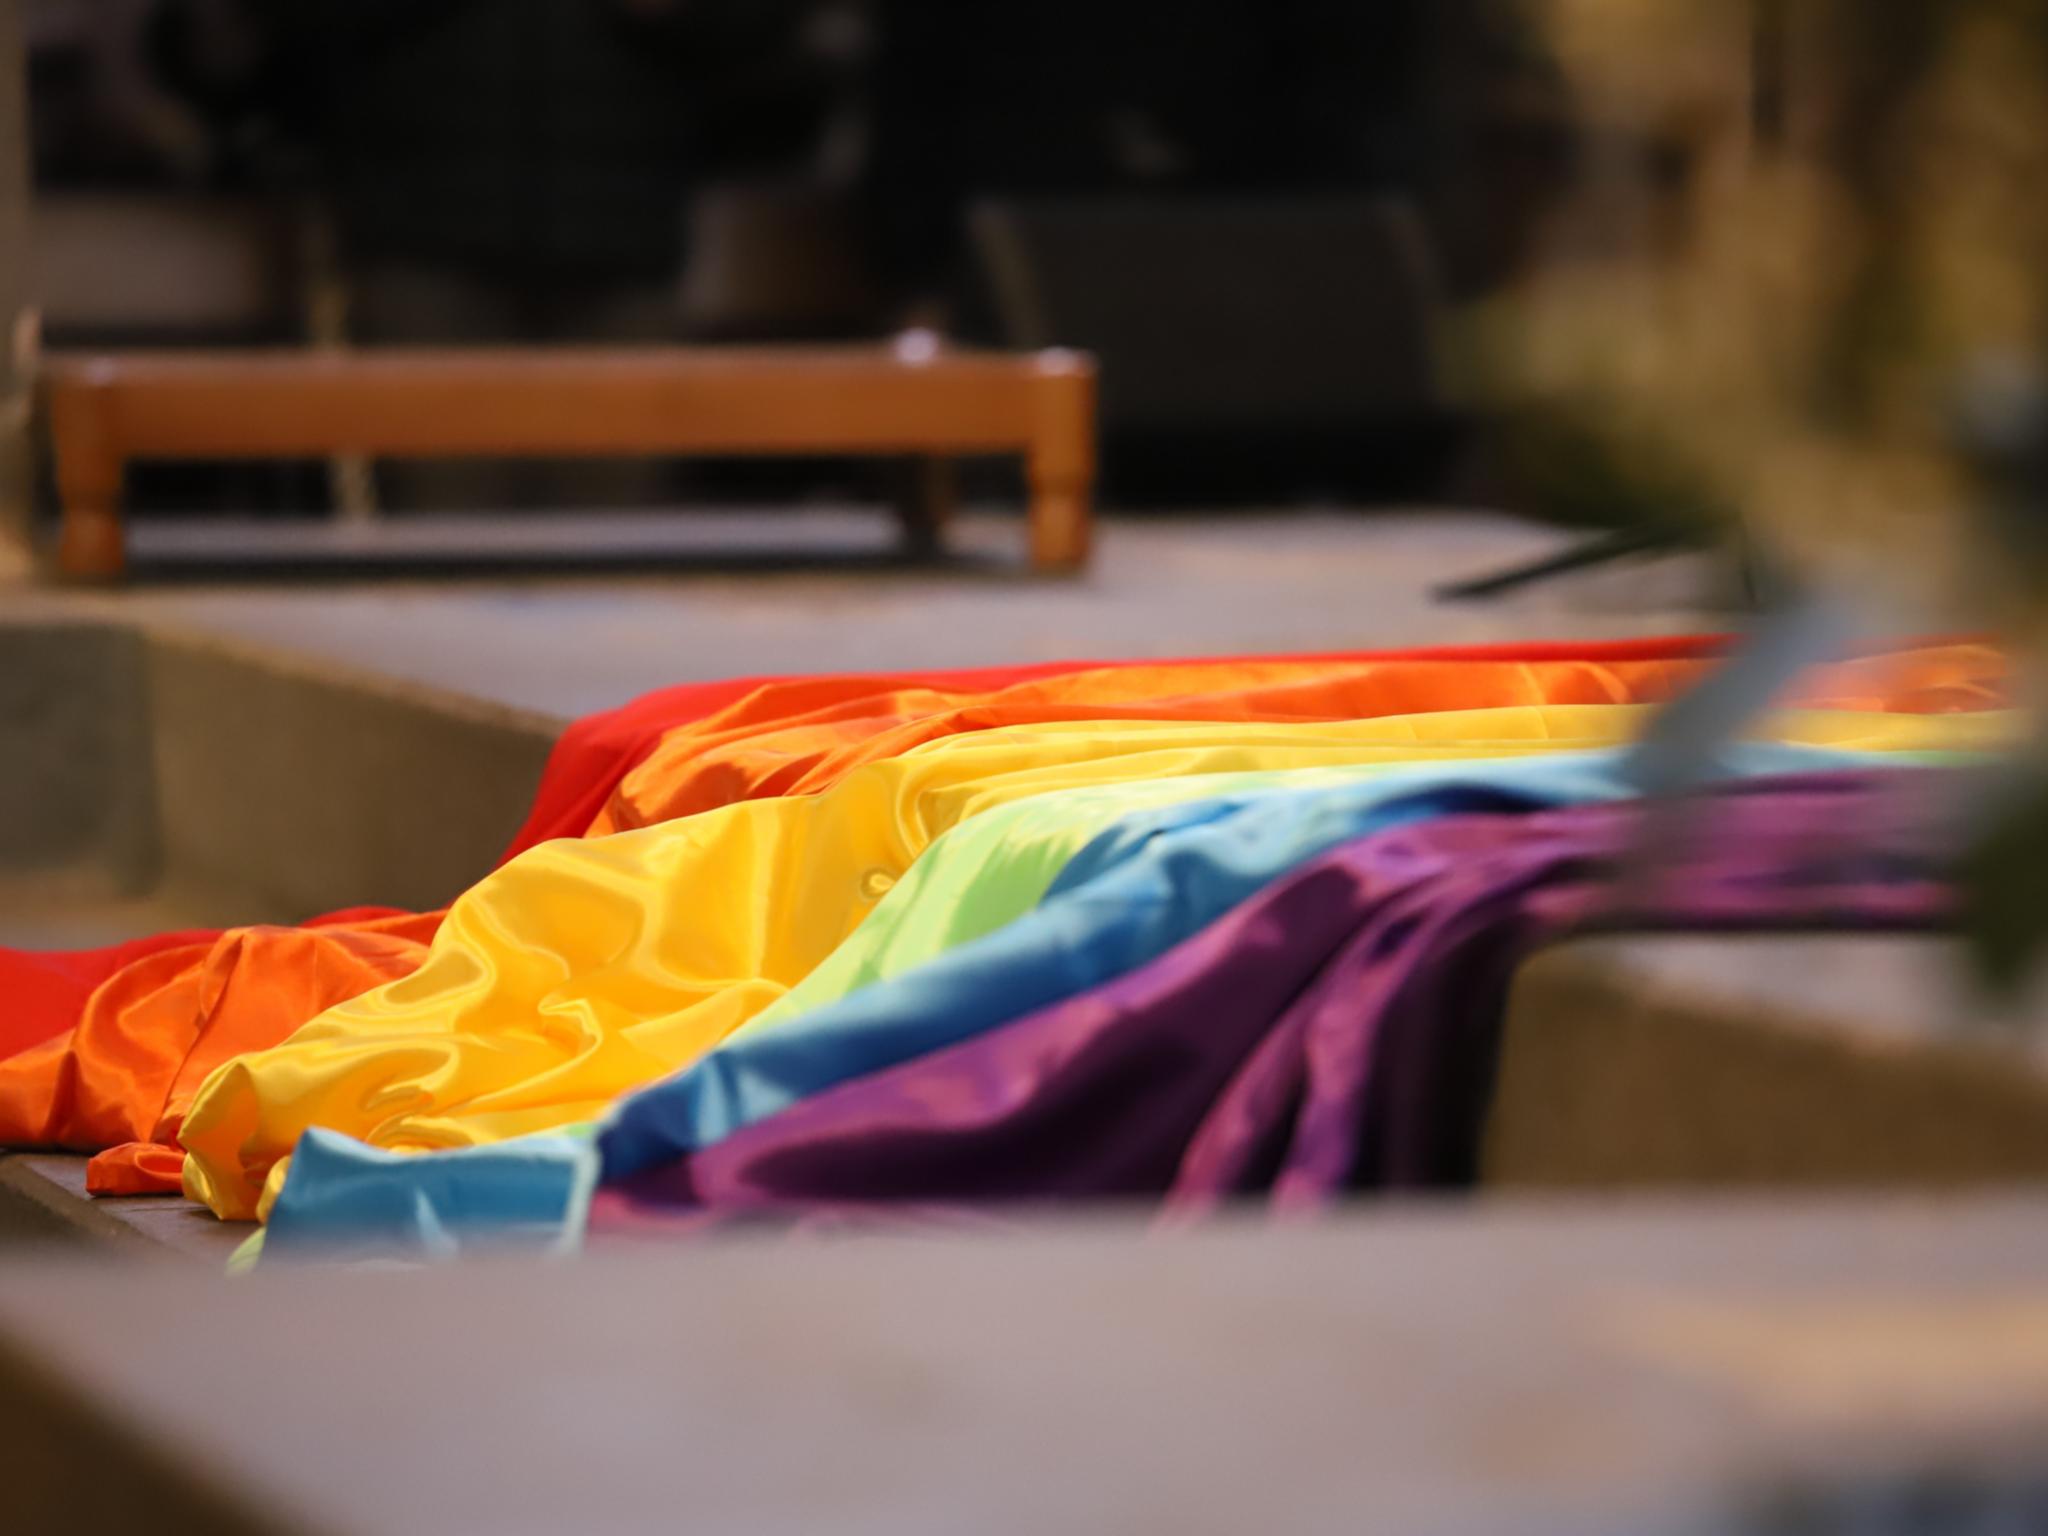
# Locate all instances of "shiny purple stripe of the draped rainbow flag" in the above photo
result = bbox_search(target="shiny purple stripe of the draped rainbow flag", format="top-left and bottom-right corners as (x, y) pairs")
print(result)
(588, 774), (1954, 1237)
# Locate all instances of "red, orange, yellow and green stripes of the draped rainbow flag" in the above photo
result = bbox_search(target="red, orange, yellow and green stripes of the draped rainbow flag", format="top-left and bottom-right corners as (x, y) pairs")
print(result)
(0, 637), (2009, 1214)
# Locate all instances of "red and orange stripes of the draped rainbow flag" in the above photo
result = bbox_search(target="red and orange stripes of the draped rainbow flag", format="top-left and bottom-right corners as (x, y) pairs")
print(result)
(0, 639), (2005, 1192)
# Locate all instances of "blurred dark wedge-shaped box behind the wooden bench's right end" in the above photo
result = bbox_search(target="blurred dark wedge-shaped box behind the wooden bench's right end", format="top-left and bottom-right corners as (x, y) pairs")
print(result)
(971, 197), (1446, 501)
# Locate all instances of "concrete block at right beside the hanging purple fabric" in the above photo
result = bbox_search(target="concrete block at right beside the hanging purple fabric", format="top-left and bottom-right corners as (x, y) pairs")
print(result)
(1481, 934), (2048, 1192)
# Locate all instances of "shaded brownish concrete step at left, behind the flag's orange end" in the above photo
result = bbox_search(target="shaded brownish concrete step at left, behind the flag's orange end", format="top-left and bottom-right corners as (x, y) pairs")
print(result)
(0, 616), (559, 1262)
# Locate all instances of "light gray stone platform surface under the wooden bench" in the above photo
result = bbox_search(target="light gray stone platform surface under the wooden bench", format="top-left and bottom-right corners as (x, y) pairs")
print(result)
(28, 510), (1729, 715)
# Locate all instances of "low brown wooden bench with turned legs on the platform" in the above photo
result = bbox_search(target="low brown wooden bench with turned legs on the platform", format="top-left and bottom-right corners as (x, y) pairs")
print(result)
(47, 344), (1096, 580)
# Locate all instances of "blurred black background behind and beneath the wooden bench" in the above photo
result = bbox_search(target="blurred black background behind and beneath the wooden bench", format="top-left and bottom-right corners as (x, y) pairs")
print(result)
(29, 0), (1573, 510)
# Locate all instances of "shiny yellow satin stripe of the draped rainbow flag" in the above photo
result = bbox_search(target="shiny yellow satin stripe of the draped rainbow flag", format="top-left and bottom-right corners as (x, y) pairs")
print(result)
(182, 705), (2005, 1217)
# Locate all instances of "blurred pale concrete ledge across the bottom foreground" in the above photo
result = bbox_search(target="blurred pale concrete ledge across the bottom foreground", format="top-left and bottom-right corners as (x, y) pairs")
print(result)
(0, 1200), (2048, 1536)
